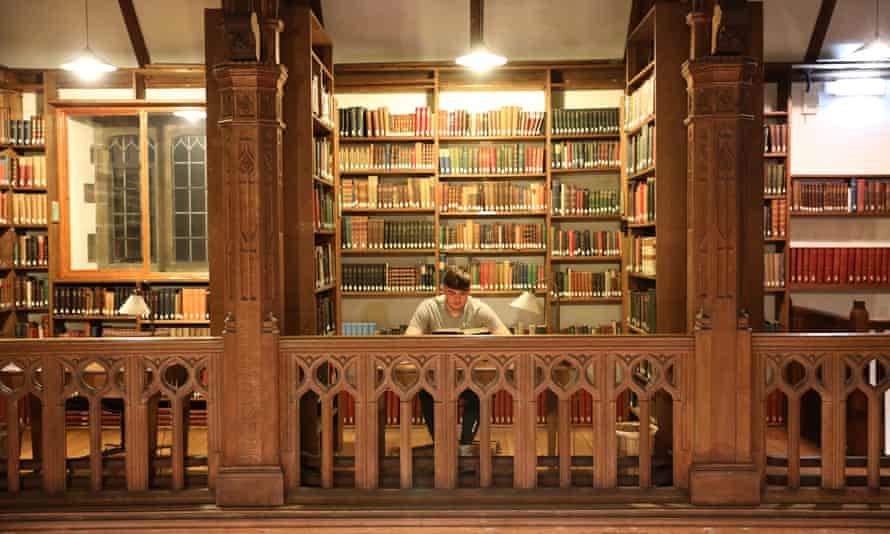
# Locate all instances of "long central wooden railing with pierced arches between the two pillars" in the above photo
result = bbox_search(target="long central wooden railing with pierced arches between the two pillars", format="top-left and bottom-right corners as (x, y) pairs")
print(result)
(281, 336), (694, 489)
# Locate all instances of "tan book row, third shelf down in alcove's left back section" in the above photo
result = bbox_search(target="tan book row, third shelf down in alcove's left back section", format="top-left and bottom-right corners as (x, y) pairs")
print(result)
(340, 175), (435, 209)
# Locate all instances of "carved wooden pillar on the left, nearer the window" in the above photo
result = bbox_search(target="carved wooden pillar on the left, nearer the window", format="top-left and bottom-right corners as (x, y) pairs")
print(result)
(214, 62), (286, 506)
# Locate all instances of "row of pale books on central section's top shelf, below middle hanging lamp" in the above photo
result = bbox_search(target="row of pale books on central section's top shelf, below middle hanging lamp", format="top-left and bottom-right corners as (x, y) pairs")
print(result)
(437, 106), (546, 137)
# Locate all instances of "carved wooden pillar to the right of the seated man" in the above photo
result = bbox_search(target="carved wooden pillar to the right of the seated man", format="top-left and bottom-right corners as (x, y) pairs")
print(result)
(683, 1), (763, 505)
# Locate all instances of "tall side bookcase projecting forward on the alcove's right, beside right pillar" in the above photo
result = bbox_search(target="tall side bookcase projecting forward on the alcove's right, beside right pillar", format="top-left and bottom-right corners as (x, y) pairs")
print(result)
(621, 1), (689, 334)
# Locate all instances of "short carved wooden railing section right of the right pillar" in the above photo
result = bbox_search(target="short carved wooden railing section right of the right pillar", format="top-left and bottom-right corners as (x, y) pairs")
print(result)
(752, 334), (890, 490)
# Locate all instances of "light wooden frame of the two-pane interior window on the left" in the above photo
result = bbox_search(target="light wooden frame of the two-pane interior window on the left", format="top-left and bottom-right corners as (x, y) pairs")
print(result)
(56, 101), (210, 282)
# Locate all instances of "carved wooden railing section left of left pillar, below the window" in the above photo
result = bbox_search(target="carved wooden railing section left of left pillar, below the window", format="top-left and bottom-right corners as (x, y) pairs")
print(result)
(0, 338), (222, 493)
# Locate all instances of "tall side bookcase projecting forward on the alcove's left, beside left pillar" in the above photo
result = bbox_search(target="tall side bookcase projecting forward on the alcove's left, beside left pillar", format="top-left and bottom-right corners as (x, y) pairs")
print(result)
(280, 5), (338, 335)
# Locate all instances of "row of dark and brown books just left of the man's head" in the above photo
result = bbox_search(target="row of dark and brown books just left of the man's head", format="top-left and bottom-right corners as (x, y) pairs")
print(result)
(342, 263), (436, 293)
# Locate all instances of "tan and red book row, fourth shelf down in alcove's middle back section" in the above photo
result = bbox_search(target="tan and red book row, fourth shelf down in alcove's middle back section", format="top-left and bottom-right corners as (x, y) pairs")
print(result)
(439, 221), (546, 250)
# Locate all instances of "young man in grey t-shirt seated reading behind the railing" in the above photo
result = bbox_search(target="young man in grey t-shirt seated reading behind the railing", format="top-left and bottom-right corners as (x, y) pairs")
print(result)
(405, 266), (510, 454)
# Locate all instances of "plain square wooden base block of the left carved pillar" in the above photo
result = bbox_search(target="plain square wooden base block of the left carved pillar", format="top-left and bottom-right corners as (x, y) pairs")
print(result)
(216, 465), (284, 506)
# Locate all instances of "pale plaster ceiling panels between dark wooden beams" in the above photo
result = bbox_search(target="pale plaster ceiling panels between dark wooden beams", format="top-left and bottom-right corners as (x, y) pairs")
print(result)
(0, 0), (890, 69)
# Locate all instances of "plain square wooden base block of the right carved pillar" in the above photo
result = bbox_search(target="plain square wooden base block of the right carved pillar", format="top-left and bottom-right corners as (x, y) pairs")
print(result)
(689, 464), (760, 506)
